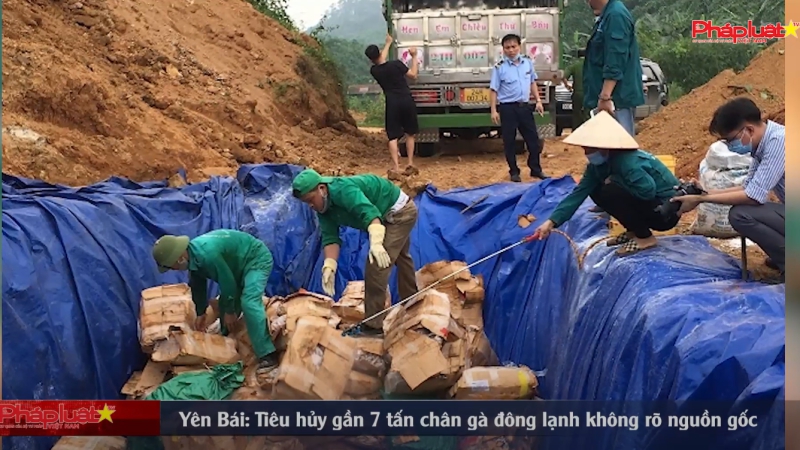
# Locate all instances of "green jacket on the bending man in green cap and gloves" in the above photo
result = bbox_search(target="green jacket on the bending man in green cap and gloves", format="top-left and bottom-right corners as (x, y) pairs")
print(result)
(318, 174), (400, 247)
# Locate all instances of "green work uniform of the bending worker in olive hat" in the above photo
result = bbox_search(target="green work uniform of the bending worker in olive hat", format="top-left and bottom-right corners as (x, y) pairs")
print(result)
(188, 230), (275, 358)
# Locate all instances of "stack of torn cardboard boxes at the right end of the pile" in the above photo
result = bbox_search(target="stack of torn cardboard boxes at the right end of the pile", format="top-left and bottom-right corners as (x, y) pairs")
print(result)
(384, 261), (538, 399)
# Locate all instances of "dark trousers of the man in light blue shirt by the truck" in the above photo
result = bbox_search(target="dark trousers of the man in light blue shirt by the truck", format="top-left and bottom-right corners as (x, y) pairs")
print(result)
(497, 102), (542, 176)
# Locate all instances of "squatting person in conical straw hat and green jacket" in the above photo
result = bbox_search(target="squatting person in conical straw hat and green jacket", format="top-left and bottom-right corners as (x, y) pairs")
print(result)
(537, 111), (680, 256)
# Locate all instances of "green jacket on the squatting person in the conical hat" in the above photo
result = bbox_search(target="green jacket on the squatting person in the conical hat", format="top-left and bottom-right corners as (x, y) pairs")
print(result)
(550, 150), (680, 226)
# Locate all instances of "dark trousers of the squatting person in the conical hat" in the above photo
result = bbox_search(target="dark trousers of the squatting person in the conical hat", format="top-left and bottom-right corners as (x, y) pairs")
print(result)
(590, 183), (679, 239)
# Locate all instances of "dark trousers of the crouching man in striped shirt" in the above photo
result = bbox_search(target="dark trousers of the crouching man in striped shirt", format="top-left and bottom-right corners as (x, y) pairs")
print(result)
(728, 203), (786, 273)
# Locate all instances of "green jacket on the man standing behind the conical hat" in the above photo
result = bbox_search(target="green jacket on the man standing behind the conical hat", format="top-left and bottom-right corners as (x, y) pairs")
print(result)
(583, 0), (644, 109)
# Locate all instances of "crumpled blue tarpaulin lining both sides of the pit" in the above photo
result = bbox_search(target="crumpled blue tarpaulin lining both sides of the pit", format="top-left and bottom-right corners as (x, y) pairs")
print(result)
(3, 165), (785, 450)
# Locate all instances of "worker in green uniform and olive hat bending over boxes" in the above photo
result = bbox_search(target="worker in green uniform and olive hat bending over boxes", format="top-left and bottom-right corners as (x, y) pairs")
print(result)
(153, 230), (279, 372)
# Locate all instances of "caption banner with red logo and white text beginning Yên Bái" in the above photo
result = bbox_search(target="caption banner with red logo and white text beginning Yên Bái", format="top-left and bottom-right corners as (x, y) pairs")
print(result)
(0, 400), (775, 441)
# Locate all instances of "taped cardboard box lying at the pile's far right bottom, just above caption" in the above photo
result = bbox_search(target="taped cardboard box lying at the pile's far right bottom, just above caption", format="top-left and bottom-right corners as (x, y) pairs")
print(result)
(450, 366), (539, 400)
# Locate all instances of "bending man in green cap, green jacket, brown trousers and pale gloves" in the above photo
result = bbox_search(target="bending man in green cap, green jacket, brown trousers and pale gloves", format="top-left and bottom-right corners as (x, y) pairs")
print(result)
(292, 169), (418, 336)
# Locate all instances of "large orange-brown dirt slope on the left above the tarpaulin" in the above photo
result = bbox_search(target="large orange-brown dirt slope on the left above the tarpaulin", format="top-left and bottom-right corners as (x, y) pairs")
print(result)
(2, 0), (385, 185)
